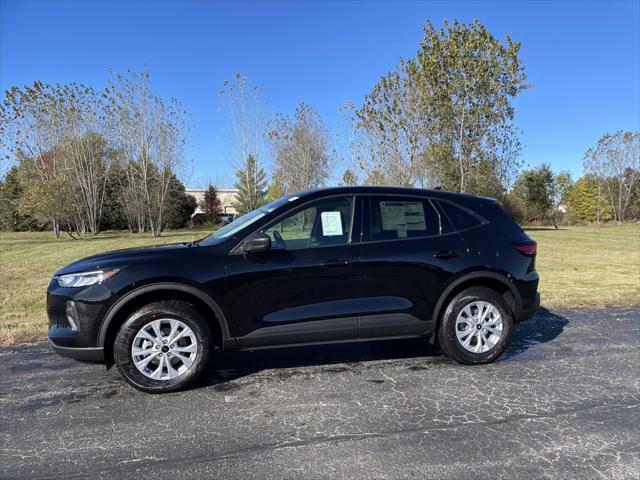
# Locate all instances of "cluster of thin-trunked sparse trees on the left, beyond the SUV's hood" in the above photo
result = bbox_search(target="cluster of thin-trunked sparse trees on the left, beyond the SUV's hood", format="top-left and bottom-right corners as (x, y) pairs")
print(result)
(0, 71), (195, 236)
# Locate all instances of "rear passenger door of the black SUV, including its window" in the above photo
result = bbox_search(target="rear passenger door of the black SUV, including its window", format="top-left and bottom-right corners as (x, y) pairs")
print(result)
(359, 195), (467, 338)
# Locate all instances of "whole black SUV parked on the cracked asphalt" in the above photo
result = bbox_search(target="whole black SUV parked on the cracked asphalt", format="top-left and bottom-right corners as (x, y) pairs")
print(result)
(47, 187), (540, 392)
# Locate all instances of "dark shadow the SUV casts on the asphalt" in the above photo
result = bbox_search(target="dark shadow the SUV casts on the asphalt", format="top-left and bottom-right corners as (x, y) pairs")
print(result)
(192, 308), (569, 391)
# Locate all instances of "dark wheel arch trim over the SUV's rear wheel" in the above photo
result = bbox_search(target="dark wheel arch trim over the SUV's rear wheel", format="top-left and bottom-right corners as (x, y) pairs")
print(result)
(432, 272), (522, 328)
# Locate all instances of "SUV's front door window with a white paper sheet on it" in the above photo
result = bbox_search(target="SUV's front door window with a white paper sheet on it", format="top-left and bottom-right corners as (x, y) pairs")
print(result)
(262, 197), (353, 250)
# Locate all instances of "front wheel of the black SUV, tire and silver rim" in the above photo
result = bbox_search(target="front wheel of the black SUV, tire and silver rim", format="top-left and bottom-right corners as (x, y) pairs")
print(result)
(113, 300), (211, 393)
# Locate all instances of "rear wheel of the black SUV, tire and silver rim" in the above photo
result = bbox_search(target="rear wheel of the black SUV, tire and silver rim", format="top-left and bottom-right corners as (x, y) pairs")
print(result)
(438, 287), (513, 365)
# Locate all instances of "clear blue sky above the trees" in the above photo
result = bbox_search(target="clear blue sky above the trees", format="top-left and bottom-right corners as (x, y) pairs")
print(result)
(0, 0), (640, 186)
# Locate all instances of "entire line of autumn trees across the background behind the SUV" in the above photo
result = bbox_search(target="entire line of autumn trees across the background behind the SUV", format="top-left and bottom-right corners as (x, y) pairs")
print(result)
(0, 20), (640, 236)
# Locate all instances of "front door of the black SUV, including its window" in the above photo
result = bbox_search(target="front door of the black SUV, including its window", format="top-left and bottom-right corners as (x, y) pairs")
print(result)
(226, 196), (361, 348)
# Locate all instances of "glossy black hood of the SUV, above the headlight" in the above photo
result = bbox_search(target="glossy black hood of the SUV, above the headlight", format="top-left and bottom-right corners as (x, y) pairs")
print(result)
(54, 243), (192, 275)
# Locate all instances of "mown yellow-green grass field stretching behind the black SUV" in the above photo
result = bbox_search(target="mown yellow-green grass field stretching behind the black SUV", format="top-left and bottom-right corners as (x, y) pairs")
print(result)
(0, 225), (640, 345)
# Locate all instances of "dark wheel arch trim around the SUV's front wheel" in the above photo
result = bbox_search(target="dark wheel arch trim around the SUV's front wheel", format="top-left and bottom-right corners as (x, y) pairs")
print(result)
(98, 282), (229, 368)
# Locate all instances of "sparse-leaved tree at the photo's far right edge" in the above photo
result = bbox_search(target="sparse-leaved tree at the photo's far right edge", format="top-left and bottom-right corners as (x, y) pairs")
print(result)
(584, 130), (640, 222)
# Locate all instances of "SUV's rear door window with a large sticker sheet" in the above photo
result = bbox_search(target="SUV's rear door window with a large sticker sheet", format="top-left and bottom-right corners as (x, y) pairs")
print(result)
(370, 196), (440, 241)
